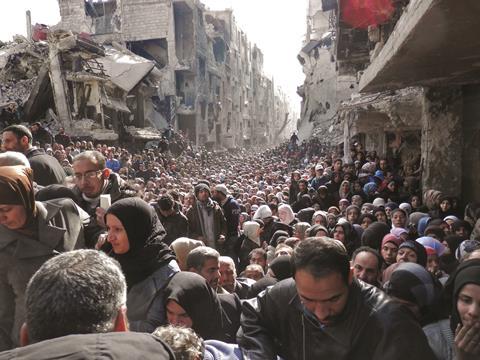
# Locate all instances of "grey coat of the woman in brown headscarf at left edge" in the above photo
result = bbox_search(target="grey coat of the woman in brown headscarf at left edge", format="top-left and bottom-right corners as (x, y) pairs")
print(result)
(0, 199), (84, 350)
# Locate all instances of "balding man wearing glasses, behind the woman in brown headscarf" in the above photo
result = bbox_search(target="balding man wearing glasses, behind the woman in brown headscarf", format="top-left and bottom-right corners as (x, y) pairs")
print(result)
(72, 151), (133, 248)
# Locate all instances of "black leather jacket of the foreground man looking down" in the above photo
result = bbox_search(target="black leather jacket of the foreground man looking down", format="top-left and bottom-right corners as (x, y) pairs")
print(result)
(238, 279), (435, 360)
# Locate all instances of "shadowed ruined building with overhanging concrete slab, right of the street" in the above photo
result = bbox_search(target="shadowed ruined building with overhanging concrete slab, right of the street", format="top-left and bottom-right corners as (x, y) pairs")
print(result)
(299, 0), (480, 200)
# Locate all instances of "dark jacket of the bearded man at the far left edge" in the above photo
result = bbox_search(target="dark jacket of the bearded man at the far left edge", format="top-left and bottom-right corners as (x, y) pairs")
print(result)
(25, 148), (66, 186)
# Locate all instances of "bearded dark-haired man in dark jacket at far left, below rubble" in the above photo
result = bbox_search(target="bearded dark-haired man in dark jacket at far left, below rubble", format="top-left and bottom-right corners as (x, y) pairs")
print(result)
(2, 125), (66, 186)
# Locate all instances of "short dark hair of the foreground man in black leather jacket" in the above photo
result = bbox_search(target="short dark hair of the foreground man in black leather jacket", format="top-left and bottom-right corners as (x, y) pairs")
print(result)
(293, 237), (350, 284)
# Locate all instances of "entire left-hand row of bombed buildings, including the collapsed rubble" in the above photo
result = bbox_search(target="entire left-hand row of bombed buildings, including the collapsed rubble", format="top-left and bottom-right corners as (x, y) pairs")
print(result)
(0, 0), (291, 148)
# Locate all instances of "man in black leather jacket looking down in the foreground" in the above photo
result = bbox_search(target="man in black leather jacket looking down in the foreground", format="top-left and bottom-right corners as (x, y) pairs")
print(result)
(238, 238), (435, 360)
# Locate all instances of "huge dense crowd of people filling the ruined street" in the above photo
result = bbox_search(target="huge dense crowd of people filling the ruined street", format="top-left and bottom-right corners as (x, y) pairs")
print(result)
(0, 125), (480, 360)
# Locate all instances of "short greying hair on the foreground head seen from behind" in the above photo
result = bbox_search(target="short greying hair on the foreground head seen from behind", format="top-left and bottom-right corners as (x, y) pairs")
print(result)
(25, 250), (127, 342)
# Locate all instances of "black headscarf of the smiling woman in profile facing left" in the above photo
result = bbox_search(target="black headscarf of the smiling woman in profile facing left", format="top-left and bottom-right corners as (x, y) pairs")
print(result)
(105, 197), (175, 289)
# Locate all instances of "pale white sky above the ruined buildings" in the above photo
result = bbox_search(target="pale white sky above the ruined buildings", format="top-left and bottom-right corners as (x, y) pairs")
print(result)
(0, 0), (308, 113)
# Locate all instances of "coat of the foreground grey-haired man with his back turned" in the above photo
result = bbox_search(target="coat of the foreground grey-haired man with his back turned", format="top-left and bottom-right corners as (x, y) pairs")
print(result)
(0, 332), (175, 360)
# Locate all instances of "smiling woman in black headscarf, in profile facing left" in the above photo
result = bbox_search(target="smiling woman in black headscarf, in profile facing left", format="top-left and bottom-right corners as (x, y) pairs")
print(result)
(105, 197), (180, 332)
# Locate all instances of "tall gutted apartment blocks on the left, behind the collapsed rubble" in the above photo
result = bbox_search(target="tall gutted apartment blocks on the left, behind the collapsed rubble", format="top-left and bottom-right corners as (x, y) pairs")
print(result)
(52, 0), (291, 148)
